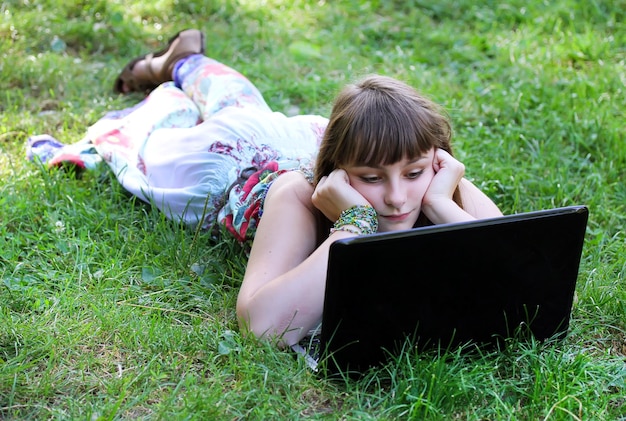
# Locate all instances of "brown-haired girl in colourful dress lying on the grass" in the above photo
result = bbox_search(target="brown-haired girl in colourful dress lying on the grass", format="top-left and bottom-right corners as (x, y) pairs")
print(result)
(29, 30), (501, 345)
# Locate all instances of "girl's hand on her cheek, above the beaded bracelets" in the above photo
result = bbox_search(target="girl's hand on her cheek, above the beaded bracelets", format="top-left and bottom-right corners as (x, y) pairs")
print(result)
(311, 169), (369, 221)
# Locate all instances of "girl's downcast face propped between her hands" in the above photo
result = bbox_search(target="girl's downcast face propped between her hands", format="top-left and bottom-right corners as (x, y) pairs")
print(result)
(344, 148), (435, 232)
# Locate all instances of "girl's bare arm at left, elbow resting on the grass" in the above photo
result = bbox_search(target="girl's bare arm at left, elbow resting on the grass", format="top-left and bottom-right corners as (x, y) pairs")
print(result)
(237, 172), (353, 345)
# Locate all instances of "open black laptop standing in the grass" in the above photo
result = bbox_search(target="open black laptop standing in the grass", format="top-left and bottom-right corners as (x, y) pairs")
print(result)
(320, 206), (588, 373)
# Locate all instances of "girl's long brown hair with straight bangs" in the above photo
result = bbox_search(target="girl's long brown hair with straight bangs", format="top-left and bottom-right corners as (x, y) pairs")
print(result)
(314, 75), (461, 236)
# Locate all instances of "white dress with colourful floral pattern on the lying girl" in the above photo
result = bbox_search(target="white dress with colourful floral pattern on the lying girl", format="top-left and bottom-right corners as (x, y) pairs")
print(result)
(29, 55), (328, 241)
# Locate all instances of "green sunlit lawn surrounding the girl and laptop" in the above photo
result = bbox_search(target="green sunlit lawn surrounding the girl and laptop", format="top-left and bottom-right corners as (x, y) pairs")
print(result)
(0, 0), (626, 420)
